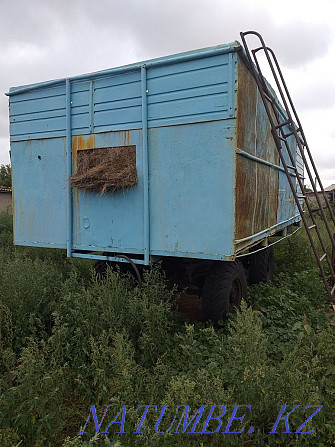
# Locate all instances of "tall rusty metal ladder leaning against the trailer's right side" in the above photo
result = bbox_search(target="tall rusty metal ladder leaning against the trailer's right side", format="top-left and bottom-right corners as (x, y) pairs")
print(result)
(240, 31), (335, 307)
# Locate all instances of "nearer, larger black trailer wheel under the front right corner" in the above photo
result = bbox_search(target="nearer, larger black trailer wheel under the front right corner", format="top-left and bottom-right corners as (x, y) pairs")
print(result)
(202, 261), (247, 321)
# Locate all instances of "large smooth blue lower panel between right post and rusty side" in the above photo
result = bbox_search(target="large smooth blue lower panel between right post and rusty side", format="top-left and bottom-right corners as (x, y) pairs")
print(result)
(149, 120), (235, 258)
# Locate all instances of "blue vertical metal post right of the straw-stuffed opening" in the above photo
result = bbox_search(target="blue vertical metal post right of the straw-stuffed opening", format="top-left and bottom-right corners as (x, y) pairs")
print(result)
(141, 64), (150, 265)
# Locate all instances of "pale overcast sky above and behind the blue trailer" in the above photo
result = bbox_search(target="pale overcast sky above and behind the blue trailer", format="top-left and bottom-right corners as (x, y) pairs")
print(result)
(0, 0), (335, 187)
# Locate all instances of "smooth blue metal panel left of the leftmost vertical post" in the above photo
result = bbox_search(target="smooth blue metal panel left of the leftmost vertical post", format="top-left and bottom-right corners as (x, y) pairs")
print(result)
(11, 138), (67, 247)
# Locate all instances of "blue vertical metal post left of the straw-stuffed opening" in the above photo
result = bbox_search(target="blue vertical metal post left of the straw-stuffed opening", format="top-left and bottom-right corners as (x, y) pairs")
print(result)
(65, 79), (72, 257)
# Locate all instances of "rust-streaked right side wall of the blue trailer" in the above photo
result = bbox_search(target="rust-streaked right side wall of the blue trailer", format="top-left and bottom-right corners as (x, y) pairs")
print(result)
(235, 54), (300, 252)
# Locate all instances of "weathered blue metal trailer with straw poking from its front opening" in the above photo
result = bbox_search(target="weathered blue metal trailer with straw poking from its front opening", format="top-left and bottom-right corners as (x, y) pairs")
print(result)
(7, 36), (303, 319)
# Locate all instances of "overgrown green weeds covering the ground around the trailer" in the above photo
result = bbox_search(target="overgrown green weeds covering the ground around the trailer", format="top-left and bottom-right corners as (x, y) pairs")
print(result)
(0, 213), (335, 447)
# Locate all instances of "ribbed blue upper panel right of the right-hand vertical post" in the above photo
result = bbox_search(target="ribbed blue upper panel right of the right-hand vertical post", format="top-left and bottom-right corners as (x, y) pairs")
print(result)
(147, 54), (233, 127)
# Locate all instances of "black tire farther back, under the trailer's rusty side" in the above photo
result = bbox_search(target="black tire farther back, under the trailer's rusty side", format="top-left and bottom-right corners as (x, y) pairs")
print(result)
(249, 247), (274, 284)
